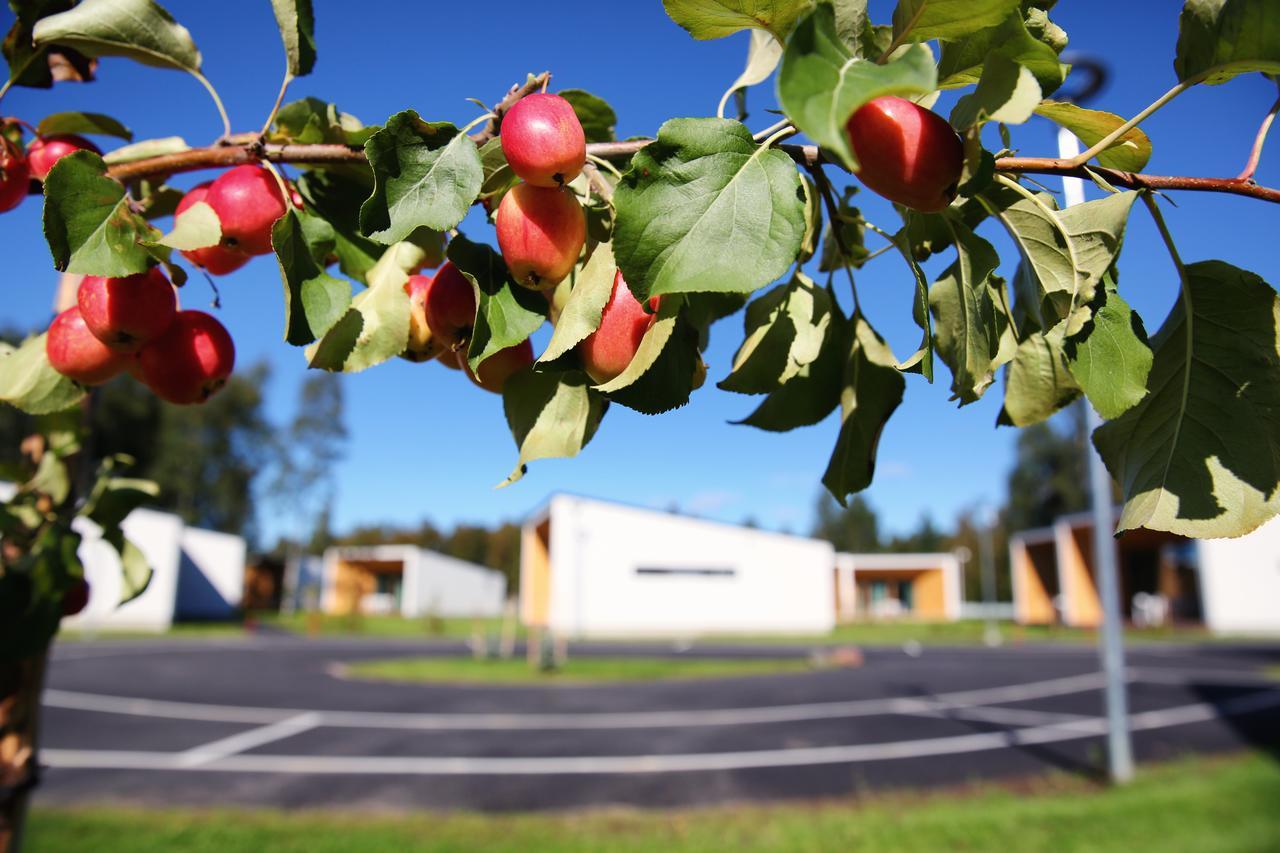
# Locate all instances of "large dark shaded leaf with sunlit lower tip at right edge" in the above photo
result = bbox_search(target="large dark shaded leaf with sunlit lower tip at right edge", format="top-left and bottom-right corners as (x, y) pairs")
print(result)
(1093, 260), (1280, 538)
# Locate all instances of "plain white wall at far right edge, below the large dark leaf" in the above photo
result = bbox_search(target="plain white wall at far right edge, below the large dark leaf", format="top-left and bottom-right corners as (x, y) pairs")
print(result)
(1198, 519), (1280, 633)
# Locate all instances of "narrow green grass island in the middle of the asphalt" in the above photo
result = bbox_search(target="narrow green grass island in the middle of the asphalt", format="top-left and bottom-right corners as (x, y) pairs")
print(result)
(343, 656), (813, 684)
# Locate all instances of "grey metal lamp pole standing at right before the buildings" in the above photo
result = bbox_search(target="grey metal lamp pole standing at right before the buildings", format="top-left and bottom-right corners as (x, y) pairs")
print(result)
(1057, 128), (1133, 784)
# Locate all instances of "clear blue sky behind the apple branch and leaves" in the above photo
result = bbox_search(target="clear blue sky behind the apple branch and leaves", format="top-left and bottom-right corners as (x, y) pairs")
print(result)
(0, 0), (1280, 535)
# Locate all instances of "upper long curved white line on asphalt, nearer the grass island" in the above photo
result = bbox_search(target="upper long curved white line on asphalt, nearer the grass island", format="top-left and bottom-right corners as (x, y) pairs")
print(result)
(44, 672), (1102, 731)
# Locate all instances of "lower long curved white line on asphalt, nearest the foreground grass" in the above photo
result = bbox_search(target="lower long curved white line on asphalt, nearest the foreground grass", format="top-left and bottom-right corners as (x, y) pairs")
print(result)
(41, 690), (1280, 776)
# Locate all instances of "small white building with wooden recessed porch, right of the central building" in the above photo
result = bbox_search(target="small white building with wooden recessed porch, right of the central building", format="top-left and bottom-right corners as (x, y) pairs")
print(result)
(836, 553), (964, 621)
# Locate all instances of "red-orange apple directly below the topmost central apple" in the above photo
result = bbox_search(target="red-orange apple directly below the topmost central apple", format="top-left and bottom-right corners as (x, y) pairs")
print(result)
(494, 183), (586, 291)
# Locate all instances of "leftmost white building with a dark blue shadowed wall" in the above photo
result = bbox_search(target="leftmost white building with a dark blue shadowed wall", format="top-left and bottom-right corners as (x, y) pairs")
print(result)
(63, 510), (244, 631)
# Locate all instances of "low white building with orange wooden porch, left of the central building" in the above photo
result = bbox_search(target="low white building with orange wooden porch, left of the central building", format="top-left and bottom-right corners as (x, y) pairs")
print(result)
(320, 546), (507, 617)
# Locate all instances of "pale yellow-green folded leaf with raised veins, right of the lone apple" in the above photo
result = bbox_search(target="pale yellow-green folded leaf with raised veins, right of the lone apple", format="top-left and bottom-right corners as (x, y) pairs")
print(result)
(979, 188), (1138, 336)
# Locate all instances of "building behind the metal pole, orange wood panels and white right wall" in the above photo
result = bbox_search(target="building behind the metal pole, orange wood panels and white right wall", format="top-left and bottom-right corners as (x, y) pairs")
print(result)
(1009, 504), (1280, 633)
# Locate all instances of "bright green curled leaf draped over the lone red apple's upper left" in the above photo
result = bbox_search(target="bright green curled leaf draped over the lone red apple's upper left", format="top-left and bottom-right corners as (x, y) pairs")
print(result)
(778, 5), (937, 172)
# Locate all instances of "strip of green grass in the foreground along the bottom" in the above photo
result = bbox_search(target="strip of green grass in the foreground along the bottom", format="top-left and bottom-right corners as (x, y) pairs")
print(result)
(28, 754), (1280, 853)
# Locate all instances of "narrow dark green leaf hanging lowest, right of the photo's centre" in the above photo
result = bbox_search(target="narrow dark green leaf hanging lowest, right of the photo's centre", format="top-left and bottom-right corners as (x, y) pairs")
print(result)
(822, 314), (906, 505)
